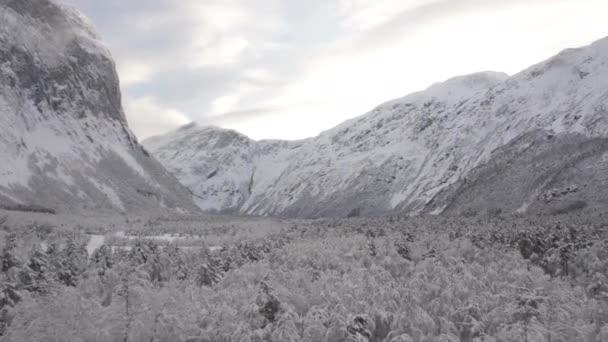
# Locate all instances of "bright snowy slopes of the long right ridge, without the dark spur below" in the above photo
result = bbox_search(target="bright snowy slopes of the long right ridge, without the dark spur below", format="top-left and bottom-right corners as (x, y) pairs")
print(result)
(144, 39), (608, 214)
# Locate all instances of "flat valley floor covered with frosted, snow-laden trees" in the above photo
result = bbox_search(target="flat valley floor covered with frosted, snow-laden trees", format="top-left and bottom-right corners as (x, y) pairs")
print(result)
(0, 213), (608, 342)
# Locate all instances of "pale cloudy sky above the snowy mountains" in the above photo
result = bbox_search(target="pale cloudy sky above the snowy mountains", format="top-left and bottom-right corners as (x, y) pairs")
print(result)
(64, 0), (608, 139)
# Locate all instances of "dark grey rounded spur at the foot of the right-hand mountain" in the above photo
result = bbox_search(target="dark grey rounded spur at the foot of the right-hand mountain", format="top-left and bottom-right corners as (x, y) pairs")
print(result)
(428, 130), (608, 216)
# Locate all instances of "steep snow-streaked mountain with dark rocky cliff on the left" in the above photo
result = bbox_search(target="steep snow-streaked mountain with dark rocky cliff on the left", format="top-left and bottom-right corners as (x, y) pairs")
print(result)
(0, 0), (198, 212)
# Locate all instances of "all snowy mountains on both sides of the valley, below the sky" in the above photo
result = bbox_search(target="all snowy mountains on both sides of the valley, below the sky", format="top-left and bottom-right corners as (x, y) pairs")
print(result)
(0, 0), (608, 217)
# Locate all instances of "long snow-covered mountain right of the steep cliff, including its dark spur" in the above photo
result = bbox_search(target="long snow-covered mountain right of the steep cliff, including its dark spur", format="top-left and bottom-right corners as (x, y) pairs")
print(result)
(144, 39), (608, 217)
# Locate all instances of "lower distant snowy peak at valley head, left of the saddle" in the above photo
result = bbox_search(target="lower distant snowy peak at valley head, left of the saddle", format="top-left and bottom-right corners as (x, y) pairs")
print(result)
(145, 124), (297, 213)
